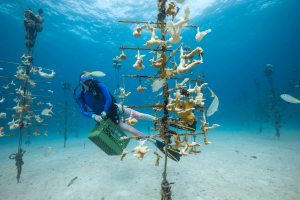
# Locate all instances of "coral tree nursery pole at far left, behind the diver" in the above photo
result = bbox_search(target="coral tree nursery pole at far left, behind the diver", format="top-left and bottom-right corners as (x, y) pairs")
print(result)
(0, 6), (55, 182)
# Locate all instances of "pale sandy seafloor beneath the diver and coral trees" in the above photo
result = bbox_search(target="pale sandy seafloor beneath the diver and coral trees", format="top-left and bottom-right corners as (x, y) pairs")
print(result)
(0, 130), (300, 200)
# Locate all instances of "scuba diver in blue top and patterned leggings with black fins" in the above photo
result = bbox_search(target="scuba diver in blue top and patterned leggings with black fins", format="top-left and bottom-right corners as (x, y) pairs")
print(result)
(73, 71), (181, 161)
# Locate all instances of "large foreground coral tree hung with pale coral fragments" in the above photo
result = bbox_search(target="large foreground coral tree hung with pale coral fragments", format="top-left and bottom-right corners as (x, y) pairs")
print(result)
(117, 0), (219, 200)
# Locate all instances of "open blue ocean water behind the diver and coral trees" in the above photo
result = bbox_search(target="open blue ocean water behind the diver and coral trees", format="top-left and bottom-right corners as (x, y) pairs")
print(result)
(0, 0), (300, 198)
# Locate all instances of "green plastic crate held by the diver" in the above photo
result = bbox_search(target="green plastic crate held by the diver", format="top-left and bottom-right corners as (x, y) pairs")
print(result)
(88, 119), (129, 156)
